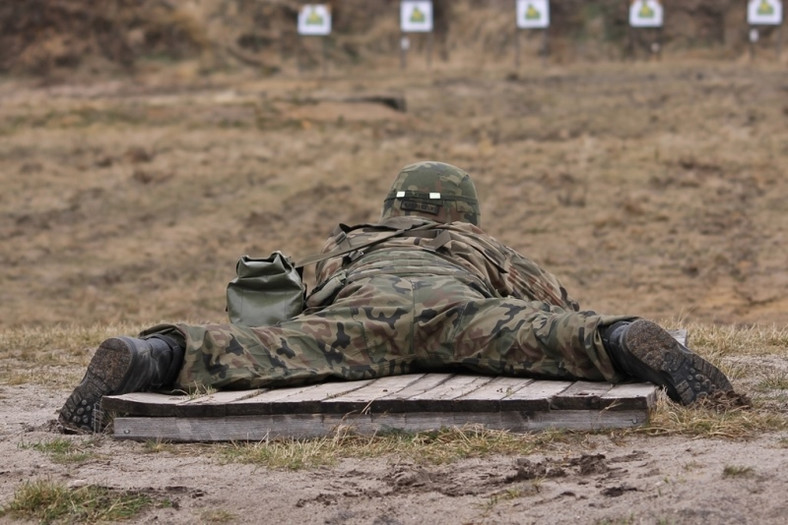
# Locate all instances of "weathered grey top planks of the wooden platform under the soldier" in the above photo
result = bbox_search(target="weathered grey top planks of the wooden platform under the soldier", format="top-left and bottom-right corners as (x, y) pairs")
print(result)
(101, 374), (656, 417)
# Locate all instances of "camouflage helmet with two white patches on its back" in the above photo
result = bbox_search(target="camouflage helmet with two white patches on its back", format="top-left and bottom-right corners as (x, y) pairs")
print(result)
(380, 161), (481, 226)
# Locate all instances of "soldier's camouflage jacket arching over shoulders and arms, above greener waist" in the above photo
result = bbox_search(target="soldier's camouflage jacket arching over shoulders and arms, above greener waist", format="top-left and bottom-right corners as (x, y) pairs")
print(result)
(307, 216), (579, 311)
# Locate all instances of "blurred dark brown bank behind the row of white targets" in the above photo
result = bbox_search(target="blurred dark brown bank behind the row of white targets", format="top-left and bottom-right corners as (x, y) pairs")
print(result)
(0, 0), (782, 77)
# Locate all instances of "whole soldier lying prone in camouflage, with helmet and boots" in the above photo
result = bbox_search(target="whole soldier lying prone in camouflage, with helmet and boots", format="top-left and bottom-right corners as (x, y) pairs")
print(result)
(58, 162), (733, 431)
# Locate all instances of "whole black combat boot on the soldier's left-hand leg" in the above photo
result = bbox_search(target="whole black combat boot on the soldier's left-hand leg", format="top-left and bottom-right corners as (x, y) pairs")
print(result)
(59, 334), (184, 432)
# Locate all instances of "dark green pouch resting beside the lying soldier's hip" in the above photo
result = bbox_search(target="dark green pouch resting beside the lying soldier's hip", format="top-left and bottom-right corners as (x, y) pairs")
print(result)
(227, 251), (306, 326)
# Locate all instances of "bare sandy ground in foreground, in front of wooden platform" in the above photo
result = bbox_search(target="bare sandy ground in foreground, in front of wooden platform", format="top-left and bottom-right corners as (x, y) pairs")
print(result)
(0, 380), (788, 524)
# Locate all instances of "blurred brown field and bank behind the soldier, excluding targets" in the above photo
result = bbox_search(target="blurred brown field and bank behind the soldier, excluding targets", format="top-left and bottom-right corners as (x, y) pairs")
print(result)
(0, 0), (788, 327)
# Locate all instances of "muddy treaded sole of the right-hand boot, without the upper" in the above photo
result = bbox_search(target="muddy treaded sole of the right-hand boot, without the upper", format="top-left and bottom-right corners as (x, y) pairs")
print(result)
(624, 319), (733, 405)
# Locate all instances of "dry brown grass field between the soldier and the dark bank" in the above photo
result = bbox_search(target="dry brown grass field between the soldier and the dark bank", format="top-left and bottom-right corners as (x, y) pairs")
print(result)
(0, 62), (788, 328)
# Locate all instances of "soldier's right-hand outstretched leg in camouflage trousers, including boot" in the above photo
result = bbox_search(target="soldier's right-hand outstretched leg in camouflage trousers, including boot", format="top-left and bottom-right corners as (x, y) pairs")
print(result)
(416, 290), (733, 405)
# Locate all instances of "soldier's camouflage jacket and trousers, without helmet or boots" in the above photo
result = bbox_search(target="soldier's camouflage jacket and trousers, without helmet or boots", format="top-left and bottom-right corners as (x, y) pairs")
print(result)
(143, 217), (633, 389)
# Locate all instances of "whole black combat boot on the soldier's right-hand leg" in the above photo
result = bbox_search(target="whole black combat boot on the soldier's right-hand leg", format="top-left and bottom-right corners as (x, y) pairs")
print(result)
(602, 319), (733, 405)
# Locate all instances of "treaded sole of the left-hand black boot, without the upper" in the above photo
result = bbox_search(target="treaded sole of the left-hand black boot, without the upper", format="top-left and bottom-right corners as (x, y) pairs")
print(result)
(58, 337), (134, 432)
